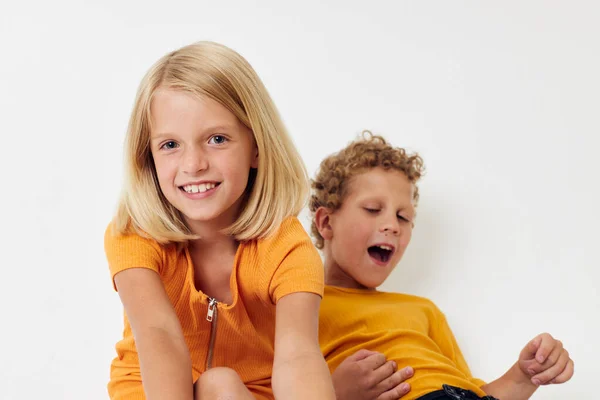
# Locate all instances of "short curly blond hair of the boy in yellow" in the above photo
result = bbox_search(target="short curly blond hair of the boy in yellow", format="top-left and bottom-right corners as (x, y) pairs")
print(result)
(309, 131), (425, 249)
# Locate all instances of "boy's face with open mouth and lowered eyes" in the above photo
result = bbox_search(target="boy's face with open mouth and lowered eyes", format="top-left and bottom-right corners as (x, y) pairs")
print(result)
(321, 168), (415, 289)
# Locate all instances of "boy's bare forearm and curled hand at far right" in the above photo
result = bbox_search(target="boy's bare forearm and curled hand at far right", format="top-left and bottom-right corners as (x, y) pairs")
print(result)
(481, 333), (574, 400)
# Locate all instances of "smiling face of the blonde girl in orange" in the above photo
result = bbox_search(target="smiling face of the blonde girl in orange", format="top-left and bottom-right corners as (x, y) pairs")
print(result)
(150, 88), (258, 235)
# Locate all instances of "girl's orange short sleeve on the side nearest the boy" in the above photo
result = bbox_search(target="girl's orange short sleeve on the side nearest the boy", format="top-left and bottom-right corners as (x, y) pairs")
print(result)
(268, 218), (325, 304)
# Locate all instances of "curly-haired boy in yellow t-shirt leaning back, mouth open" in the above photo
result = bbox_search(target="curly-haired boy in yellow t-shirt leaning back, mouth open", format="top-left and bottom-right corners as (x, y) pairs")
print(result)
(310, 132), (574, 400)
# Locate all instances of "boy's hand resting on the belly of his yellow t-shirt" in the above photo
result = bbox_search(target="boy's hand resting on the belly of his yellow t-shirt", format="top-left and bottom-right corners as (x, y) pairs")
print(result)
(331, 349), (413, 400)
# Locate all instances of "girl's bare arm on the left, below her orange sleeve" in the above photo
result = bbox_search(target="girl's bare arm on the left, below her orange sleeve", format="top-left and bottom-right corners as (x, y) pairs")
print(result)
(114, 268), (193, 400)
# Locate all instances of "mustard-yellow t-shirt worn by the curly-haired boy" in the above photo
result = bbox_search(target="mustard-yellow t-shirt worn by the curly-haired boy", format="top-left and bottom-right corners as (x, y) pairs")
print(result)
(319, 286), (485, 400)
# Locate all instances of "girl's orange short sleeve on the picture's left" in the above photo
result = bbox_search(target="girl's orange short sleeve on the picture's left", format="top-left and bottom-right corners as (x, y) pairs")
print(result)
(104, 224), (163, 290)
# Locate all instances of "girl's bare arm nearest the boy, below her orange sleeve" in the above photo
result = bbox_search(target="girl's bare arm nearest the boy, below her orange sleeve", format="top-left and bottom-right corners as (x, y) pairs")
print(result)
(272, 292), (335, 400)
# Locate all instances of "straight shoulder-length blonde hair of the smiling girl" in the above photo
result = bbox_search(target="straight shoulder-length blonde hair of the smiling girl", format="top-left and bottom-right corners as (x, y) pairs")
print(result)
(115, 42), (309, 244)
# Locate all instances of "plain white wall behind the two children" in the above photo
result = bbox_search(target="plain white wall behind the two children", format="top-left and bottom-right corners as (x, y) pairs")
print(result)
(0, 0), (600, 400)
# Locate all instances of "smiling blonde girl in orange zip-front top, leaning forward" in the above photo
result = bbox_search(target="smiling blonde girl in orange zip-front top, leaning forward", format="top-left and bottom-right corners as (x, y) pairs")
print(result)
(105, 42), (335, 400)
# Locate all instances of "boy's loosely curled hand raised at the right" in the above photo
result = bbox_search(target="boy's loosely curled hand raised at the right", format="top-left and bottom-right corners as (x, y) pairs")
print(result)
(518, 333), (574, 386)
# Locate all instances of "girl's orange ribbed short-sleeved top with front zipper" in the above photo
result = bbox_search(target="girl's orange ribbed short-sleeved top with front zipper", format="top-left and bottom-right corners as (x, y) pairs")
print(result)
(104, 217), (324, 400)
